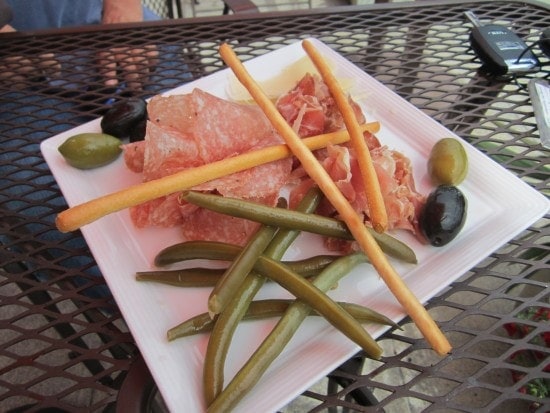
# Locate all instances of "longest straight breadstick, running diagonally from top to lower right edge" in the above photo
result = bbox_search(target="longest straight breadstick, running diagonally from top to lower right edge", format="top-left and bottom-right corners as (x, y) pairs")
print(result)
(219, 43), (451, 354)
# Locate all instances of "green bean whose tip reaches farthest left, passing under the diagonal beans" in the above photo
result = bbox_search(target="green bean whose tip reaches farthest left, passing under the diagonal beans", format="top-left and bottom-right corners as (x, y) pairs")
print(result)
(136, 255), (338, 287)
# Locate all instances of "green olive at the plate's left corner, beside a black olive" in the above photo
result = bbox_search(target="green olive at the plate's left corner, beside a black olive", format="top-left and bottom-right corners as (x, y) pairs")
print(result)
(58, 133), (122, 169)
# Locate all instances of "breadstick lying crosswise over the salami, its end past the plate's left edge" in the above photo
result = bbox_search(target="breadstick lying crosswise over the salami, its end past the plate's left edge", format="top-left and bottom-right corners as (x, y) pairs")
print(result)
(55, 122), (380, 232)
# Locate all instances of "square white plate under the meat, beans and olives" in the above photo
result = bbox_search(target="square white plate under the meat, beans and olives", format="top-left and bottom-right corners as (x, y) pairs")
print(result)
(41, 39), (549, 412)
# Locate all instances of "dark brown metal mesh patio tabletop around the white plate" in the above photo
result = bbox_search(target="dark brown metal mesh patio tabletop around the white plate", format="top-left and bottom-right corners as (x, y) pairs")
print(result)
(0, 1), (550, 412)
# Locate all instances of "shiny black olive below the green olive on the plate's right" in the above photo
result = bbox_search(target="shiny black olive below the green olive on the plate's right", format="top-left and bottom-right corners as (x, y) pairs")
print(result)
(420, 185), (467, 247)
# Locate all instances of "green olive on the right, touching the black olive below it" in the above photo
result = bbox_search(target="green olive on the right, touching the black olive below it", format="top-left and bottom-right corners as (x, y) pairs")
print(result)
(428, 138), (468, 185)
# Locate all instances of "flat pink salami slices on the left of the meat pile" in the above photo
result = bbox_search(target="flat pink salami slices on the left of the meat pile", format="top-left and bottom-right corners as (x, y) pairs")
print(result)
(124, 89), (292, 238)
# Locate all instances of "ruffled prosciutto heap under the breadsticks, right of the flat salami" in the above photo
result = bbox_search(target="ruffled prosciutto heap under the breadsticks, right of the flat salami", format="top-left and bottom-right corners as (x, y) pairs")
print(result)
(277, 75), (425, 238)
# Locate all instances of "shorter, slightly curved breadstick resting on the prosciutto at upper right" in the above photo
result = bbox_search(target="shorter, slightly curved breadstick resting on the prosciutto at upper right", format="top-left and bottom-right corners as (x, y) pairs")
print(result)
(302, 40), (388, 232)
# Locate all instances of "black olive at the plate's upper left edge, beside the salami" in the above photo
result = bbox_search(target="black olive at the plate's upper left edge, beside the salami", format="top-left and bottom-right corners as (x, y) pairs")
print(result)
(101, 98), (147, 141)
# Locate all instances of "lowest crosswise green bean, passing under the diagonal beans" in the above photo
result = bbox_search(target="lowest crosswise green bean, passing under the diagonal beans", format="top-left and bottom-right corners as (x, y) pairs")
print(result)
(167, 299), (399, 341)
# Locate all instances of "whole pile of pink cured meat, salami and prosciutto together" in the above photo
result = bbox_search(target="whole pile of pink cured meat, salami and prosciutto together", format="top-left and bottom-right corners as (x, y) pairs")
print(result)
(124, 75), (424, 250)
